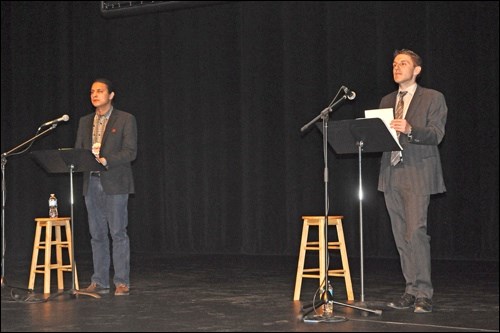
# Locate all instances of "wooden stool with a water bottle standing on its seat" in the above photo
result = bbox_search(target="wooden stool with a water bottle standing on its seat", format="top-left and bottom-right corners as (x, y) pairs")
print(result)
(28, 217), (79, 294)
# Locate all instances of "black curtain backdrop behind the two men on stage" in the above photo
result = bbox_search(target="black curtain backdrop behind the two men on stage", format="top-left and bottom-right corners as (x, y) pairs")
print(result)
(1, 1), (499, 263)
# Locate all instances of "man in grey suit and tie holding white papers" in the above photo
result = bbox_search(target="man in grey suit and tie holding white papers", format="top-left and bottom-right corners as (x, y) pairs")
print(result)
(378, 49), (448, 313)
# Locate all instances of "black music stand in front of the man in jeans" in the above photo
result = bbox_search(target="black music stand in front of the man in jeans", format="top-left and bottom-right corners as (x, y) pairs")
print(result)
(31, 148), (106, 298)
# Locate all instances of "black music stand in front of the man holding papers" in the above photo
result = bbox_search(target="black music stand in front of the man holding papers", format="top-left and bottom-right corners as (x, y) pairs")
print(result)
(318, 118), (402, 312)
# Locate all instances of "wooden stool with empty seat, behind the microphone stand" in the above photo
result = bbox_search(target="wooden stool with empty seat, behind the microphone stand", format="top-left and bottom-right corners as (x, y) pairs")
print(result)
(293, 216), (354, 301)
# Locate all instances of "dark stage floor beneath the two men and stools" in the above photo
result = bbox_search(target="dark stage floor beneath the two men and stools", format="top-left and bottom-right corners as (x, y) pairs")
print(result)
(1, 255), (499, 332)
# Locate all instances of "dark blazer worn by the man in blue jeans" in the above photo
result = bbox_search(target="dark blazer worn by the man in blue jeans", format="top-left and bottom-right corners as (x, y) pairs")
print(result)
(75, 109), (137, 195)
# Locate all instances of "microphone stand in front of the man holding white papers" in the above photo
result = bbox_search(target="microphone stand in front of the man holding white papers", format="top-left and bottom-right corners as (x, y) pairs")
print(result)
(301, 93), (347, 322)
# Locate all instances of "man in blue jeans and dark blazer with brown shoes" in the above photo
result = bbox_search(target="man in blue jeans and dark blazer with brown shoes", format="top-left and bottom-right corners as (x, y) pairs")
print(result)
(75, 79), (137, 296)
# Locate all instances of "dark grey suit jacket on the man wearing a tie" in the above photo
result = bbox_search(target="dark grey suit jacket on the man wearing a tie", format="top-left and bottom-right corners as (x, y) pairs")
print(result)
(378, 85), (448, 195)
